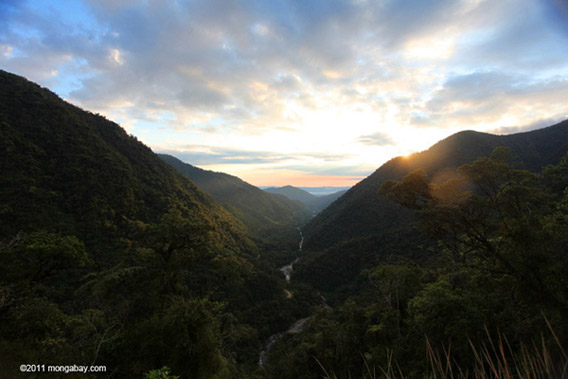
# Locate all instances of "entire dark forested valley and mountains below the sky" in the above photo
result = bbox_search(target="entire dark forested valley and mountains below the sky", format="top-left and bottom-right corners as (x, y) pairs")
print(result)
(0, 71), (568, 378)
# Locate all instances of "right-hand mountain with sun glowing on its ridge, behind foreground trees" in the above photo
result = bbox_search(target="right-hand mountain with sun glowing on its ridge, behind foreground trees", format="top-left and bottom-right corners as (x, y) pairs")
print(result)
(294, 121), (568, 292)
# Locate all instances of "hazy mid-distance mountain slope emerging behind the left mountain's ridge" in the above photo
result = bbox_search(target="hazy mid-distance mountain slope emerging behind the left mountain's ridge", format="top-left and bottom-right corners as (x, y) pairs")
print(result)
(158, 154), (310, 245)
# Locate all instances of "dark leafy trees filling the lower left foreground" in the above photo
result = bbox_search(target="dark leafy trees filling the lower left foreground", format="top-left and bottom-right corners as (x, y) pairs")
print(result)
(0, 211), (316, 378)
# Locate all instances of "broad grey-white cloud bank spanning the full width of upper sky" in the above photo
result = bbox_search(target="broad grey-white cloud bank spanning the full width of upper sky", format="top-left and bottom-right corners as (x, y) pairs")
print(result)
(0, 0), (568, 140)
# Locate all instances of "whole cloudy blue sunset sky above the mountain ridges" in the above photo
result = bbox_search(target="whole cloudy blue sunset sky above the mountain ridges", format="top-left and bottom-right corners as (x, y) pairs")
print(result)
(0, 0), (568, 186)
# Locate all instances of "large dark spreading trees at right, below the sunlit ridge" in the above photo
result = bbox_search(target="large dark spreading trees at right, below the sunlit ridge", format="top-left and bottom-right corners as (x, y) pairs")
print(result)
(380, 148), (568, 350)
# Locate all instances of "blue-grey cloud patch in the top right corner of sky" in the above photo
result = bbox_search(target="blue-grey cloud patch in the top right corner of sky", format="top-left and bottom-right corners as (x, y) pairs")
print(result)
(453, 0), (568, 72)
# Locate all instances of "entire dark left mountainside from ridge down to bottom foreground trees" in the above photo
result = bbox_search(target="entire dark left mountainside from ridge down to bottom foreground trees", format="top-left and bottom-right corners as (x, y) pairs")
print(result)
(0, 71), (316, 378)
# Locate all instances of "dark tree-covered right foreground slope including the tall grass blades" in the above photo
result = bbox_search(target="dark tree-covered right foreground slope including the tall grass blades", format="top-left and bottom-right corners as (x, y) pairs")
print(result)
(269, 146), (568, 378)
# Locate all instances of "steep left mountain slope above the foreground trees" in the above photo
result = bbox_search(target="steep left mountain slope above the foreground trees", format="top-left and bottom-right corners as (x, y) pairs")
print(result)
(0, 72), (253, 262)
